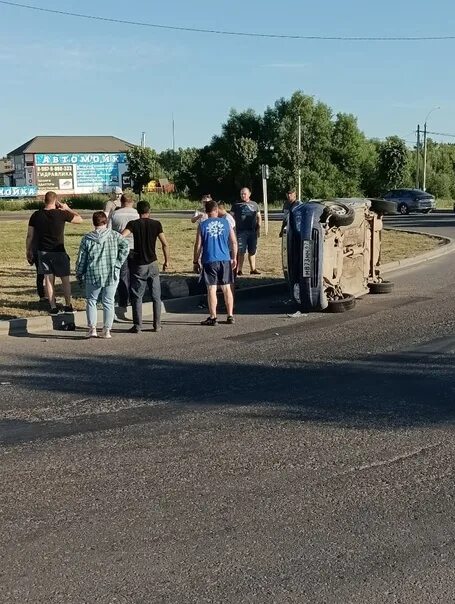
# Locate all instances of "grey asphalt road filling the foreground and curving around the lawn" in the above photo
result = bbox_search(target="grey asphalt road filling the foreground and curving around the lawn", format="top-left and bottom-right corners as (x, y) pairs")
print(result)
(0, 214), (455, 604)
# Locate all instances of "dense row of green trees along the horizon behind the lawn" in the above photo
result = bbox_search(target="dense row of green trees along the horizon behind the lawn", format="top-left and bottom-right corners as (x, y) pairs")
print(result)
(129, 91), (455, 200)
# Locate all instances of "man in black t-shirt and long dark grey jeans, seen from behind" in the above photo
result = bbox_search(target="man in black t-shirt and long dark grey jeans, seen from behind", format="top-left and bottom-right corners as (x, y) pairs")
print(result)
(122, 201), (169, 333)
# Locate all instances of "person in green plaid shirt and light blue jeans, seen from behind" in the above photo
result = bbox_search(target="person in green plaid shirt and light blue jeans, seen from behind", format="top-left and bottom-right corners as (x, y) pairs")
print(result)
(76, 212), (129, 338)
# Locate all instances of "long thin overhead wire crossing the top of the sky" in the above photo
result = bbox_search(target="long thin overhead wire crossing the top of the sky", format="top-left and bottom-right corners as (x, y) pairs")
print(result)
(0, 0), (455, 42)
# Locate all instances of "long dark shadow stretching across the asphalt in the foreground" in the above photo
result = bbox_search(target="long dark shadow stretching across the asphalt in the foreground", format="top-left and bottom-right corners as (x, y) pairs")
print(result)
(0, 352), (455, 445)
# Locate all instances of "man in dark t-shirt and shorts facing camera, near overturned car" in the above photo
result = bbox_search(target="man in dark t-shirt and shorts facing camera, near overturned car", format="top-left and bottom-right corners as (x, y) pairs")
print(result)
(232, 187), (261, 275)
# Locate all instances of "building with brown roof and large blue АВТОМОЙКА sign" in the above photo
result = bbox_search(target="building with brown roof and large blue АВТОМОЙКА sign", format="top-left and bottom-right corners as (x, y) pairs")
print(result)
(7, 136), (133, 195)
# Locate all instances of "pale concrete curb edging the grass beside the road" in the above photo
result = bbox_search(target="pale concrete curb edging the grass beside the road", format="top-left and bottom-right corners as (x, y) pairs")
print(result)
(0, 229), (455, 337)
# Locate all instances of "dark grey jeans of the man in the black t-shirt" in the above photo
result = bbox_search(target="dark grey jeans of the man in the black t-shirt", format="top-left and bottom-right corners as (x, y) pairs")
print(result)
(130, 262), (161, 328)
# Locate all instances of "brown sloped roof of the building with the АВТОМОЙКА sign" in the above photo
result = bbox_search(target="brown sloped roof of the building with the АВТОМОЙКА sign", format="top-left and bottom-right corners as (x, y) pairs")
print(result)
(8, 136), (134, 157)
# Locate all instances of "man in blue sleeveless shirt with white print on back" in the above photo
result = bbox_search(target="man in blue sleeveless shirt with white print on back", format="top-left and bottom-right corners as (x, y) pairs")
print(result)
(193, 199), (237, 326)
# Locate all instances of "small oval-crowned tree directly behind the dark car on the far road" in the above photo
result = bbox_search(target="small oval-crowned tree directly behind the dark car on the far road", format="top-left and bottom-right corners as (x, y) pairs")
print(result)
(378, 136), (409, 190)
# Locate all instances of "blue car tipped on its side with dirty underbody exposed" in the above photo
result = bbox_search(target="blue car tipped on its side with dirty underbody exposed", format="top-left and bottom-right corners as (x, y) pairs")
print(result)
(282, 199), (396, 312)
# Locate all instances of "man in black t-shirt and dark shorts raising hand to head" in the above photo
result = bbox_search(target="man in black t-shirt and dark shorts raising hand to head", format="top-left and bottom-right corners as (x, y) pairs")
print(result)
(26, 191), (82, 315)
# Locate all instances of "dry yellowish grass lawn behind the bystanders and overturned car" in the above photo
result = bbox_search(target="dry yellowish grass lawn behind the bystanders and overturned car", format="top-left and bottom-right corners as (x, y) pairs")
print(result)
(0, 219), (439, 320)
